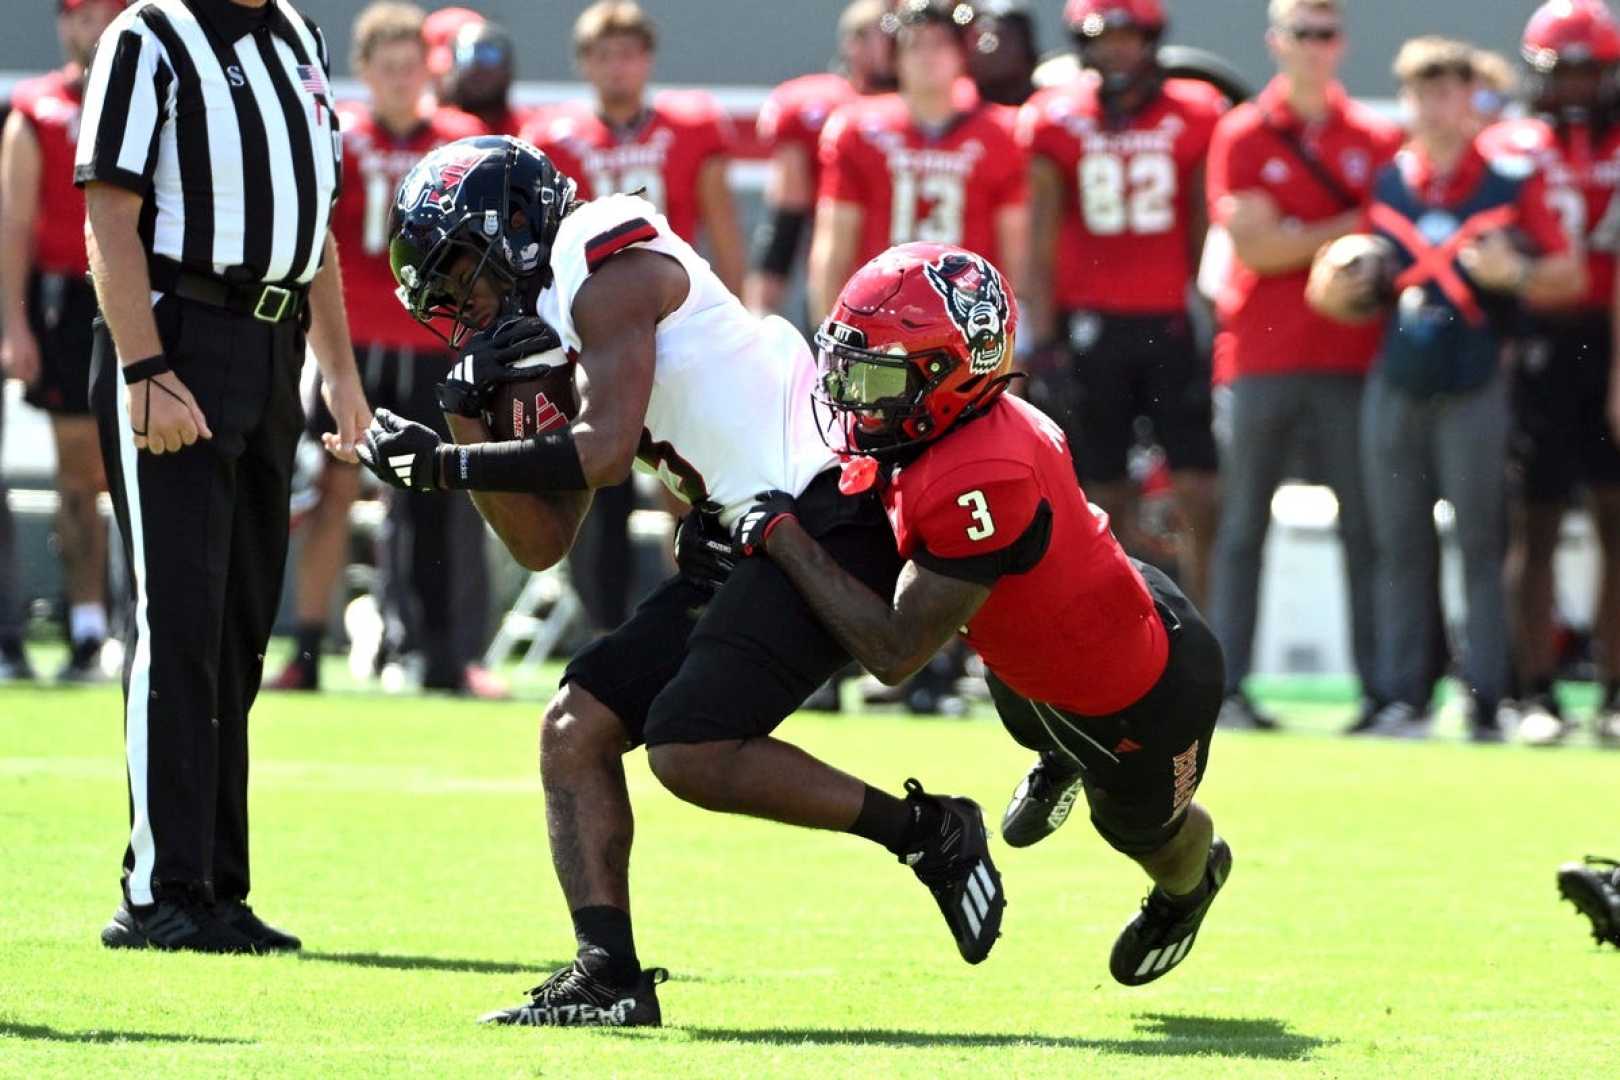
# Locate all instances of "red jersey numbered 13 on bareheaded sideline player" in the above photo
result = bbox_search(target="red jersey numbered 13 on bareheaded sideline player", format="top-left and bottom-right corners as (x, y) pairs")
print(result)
(818, 94), (1029, 266)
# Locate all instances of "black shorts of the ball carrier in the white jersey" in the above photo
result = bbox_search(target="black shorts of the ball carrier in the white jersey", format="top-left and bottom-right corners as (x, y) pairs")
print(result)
(562, 470), (901, 746)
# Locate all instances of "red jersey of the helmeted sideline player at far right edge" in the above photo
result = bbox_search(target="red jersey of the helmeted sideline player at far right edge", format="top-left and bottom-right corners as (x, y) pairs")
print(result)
(1479, 120), (1620, 311)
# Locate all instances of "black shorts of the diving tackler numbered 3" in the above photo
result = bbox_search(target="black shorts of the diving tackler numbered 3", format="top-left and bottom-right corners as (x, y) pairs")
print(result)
(985, 562), (1226, 855)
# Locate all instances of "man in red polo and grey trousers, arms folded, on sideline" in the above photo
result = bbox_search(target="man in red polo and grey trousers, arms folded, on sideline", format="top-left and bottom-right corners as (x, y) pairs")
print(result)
(1209, 0), (1401, 727)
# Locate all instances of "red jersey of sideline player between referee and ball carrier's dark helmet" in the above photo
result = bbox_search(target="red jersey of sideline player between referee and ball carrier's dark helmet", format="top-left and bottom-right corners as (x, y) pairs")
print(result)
(332, 104), (483, 350)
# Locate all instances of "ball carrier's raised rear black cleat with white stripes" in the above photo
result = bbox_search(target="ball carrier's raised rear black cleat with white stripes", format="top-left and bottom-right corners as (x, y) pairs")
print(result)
(901, 780), (1008, 963)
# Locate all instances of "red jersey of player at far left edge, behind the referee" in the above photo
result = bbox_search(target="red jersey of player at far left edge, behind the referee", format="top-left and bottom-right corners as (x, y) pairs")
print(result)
(11, 70), (89, 275)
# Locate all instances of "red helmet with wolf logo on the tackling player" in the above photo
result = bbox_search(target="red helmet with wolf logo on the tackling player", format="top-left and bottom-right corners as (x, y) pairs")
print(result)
(815, 243), (1017, 455)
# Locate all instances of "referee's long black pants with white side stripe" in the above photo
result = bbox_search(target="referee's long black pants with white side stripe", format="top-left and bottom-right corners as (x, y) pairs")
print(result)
(91, 296), (305, 904)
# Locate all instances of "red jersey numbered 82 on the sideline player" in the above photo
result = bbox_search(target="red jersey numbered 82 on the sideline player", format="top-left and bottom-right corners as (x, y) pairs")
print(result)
(1017, 76), (1226, 314)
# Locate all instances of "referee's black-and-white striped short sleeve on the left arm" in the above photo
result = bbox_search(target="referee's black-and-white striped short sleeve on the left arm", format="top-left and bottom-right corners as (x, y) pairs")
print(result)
(73, 19), (173, 193)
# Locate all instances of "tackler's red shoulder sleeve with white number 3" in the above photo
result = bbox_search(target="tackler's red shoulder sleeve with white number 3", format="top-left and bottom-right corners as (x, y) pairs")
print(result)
(907, 461), (1051, 585)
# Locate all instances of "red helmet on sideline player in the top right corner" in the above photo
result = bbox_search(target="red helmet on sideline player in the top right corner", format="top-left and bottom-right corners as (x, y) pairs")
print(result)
(1521, 0), (1620, 118)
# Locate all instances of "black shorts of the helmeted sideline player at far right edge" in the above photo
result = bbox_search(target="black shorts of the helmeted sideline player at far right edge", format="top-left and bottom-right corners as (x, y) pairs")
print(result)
(1508, 314), (1620, 504)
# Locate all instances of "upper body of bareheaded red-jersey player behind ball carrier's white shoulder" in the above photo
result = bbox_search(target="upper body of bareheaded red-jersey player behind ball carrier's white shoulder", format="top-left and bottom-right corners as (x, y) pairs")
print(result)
(523, 2), (744, 293)
